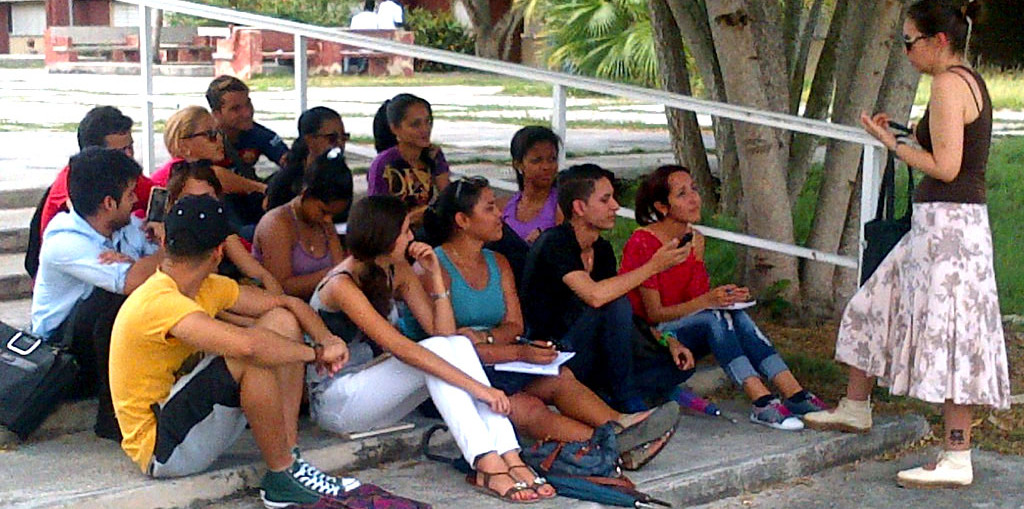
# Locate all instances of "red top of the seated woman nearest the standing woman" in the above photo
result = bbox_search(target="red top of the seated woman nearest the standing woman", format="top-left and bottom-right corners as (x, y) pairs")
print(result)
(618, 228), (711, 324)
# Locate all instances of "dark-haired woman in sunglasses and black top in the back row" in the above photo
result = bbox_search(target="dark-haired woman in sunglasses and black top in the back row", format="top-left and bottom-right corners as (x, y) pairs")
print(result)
(266, 107), (349, 210)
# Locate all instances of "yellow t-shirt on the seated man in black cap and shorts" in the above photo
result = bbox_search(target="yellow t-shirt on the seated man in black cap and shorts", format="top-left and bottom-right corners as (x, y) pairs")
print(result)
(110, 270), (239, 472)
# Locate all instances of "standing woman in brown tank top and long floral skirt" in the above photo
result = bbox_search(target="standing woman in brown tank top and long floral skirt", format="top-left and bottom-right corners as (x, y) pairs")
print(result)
(805, 0), (1010, 487)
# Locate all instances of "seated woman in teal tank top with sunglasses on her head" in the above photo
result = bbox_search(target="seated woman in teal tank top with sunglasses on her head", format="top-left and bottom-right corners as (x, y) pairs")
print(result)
(424, 178), (649, 441)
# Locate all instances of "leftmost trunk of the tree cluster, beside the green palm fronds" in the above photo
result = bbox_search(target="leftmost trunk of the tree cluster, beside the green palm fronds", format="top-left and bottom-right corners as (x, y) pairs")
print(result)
(647, 0), (719, 211)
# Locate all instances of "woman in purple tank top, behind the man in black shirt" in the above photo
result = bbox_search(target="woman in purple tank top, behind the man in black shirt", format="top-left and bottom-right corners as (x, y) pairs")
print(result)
(502, 126), (563, 244)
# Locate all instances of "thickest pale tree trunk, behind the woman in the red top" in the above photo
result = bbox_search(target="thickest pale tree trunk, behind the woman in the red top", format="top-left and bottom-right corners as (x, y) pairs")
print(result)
(708, 0), (800, 301)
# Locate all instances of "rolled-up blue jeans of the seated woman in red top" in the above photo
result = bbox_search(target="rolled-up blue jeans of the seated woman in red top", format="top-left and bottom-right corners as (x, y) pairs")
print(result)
(657, 309), (790, 386)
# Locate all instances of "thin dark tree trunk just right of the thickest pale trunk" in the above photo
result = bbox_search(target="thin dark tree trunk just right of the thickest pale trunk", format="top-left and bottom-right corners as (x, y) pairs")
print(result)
(786, 0), (847, 204)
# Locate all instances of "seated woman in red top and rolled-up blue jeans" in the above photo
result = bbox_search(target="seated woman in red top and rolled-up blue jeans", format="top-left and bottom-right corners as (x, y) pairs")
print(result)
(621, 165), (824, 430)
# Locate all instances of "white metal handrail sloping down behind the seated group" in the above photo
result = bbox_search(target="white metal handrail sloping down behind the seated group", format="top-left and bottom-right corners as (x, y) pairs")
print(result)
(118, 0), (885, 268)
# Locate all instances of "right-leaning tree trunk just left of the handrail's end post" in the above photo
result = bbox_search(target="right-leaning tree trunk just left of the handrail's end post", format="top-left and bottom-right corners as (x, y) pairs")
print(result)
(802, 0), (902, 307)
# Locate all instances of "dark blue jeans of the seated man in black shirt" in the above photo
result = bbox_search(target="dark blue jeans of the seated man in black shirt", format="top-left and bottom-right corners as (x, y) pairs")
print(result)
(559, 297), (693, 409)
